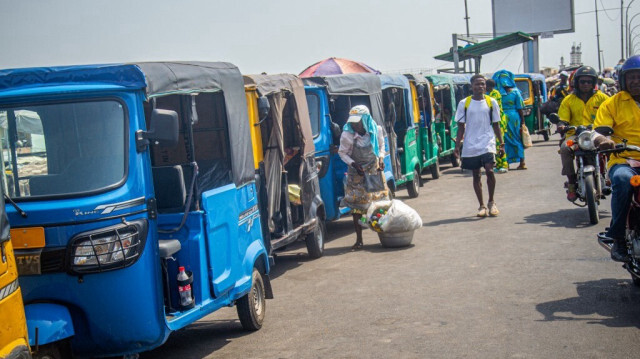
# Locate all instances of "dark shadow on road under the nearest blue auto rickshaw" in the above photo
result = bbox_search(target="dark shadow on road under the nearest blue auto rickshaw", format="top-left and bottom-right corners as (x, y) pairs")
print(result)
(140, 319), (251, 359)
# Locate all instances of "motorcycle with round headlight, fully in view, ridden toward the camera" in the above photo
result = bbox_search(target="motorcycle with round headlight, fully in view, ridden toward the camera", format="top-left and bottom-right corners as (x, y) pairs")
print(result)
(550, 114), (611, 224)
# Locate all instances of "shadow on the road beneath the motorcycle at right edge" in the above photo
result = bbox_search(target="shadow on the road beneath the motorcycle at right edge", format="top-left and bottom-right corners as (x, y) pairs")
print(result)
(536, 278), (640, 328)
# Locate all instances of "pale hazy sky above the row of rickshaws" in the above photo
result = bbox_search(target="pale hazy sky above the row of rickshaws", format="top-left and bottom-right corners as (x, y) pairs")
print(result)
(0, 0), (640, 74)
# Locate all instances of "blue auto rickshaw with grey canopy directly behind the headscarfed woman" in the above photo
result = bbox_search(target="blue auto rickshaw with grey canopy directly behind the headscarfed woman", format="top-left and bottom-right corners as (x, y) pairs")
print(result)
(303, 73), (395, 221)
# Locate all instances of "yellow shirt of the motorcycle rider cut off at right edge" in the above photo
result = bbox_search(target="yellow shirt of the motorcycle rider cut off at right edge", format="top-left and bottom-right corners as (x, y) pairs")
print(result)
(593, 91), (640, 168)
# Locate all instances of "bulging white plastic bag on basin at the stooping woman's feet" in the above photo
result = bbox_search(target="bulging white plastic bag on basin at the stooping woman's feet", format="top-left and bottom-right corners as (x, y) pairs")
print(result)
(367, 199), (422, 233)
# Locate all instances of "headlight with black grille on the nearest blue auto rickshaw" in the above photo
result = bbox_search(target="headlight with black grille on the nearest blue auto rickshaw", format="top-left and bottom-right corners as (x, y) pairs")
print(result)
(69, 220), (147, 274)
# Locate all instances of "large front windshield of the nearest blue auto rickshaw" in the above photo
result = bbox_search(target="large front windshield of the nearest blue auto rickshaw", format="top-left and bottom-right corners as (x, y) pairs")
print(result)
(0, 100), (126, 198)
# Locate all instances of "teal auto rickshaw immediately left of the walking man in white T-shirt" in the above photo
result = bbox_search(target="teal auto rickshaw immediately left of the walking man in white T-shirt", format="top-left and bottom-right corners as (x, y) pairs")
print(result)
(426, 74), (462, 167)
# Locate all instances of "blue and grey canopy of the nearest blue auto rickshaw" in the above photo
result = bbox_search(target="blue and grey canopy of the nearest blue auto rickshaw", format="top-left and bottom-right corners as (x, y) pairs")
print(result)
(0, 62), (254, 186)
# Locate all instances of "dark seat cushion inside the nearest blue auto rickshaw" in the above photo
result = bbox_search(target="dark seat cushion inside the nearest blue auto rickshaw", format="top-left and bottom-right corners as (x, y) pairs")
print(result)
(152, 165), (187, 212)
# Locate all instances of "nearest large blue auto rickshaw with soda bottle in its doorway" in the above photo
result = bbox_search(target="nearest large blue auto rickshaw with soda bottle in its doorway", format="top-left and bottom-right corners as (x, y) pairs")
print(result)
(0, 62), (272, 358)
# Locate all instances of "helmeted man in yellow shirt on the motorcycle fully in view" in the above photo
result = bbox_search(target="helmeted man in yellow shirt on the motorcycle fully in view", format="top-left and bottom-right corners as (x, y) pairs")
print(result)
(558, 66), (609, 202)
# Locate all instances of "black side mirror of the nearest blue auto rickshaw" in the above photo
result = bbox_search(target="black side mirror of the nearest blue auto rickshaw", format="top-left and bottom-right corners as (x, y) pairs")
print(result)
(136, 109), (179, 152)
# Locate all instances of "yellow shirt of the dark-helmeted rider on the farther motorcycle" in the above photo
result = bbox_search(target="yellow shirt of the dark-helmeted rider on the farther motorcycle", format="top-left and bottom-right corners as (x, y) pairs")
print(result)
(558, 91), (609, 136)
